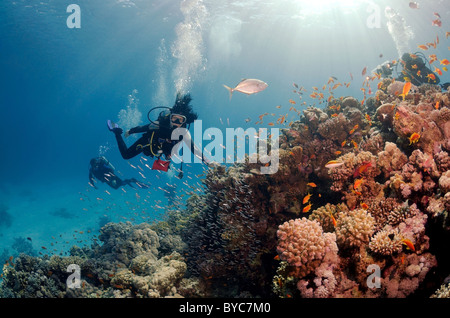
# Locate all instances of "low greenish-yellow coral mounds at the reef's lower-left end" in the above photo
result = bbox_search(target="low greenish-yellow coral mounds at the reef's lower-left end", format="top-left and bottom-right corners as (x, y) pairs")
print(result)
(0, 222), (201, 298)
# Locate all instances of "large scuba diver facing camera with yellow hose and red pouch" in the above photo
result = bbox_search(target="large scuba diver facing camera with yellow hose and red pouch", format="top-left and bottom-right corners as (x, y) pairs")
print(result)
(108, 93), (210, 178)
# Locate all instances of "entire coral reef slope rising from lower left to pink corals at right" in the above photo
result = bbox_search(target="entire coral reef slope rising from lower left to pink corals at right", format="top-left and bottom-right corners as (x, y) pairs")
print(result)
(0, 79), (450, 298)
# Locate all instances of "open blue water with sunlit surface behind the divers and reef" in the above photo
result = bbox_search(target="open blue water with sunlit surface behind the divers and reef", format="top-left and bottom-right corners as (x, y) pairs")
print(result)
(0, 0), (450, 254)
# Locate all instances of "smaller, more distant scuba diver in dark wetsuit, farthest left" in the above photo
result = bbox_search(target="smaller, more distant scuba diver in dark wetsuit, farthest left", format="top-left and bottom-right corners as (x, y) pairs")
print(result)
(89, 156), (149, 190)
